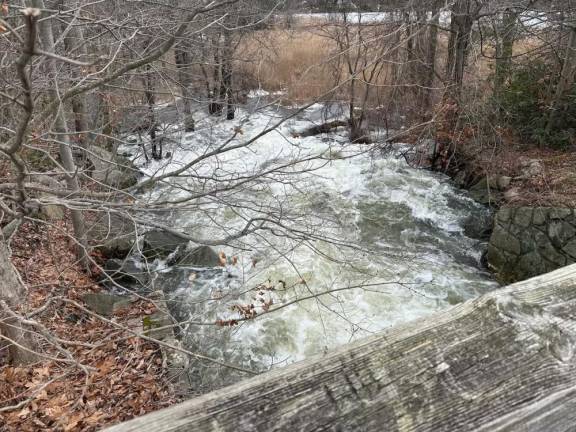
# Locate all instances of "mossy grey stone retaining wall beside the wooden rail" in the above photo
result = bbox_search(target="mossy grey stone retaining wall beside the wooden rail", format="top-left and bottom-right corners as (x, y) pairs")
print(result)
(487, 207), (576, 282)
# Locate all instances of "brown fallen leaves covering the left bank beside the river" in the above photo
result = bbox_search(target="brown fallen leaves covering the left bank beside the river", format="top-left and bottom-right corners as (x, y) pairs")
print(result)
(0, 223), (175, 432)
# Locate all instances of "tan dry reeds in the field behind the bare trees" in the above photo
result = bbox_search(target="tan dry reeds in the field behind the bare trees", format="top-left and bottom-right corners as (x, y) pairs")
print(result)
(237, 23), (541, 106)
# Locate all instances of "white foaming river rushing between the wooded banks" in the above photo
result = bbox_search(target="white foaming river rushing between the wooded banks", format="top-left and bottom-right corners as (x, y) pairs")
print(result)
(124, 99), (496, 389)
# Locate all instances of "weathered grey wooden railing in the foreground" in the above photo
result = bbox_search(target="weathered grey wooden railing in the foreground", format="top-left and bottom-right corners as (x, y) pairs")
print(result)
(106, 265), (576, 432)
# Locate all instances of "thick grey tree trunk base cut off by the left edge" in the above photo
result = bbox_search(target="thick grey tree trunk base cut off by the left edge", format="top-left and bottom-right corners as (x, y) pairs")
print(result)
(0, 238), (39, 365)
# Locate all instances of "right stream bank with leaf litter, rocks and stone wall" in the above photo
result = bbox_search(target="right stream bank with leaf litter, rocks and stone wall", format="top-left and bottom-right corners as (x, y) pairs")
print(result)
(414, 140), (576, 283)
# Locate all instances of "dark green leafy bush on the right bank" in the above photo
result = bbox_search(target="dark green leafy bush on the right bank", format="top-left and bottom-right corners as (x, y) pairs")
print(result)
(498, 62), (576, 148)
